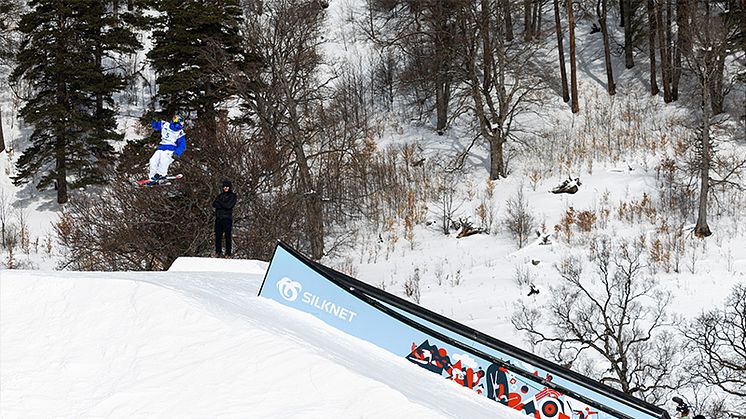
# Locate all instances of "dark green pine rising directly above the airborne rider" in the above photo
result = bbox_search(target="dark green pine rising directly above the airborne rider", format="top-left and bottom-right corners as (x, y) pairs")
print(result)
(148, 0), (246, 141)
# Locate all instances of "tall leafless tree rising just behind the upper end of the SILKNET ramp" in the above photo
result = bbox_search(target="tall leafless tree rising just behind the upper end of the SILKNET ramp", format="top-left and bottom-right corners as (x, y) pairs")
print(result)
(246, 0), (330, 259)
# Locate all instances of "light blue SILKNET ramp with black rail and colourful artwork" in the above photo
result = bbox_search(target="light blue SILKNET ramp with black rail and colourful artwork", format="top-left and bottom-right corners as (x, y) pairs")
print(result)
(259, 242), (670, 419)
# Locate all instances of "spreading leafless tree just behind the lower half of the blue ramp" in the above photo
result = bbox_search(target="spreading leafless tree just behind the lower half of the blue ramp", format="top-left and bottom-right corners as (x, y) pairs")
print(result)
(512, 238), (679, 401)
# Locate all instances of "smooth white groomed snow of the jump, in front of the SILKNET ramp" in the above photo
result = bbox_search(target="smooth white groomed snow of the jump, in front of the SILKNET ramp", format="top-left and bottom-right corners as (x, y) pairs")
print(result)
(0, 258), (525, 419)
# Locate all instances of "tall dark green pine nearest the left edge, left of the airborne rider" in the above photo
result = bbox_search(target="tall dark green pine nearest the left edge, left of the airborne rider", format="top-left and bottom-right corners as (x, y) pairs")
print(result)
(11, 0), (136, 203)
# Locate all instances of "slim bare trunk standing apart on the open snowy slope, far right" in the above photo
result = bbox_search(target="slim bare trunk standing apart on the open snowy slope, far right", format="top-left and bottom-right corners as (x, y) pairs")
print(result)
(694, 76), (712, 238)
